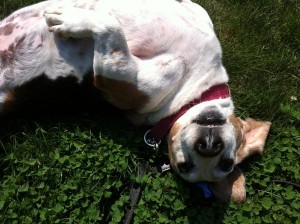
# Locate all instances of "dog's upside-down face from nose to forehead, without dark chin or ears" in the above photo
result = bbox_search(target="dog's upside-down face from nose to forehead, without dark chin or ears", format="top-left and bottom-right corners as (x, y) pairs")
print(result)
(171, 123), (235, 182)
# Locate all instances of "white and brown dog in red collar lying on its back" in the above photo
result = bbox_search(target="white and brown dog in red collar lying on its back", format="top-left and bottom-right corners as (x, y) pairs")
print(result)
(0, 0), (271, 202)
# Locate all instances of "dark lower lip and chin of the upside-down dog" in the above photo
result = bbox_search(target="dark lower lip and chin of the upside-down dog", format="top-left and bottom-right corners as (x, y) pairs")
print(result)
(194, 108), (226, 126)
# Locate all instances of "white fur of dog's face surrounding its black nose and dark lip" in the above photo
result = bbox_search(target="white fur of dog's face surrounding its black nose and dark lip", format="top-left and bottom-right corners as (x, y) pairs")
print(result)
(169, 98), (237, 182)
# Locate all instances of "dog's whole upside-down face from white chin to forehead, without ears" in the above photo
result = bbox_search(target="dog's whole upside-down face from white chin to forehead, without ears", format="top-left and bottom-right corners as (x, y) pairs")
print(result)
(165, 102), (237, 183)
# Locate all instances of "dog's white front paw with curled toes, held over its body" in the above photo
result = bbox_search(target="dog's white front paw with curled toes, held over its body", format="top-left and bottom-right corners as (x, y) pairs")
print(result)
(44, 7), (91, 38)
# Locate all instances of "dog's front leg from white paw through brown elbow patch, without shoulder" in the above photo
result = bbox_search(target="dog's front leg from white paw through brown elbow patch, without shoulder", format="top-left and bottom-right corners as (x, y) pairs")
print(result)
(44, 5), (148, 110)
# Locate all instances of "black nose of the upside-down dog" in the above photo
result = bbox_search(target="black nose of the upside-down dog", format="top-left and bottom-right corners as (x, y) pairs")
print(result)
(194, 128), (225, 157)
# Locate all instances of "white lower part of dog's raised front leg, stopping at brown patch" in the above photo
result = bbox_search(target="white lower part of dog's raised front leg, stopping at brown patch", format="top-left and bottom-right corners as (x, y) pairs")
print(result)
(44, 7), (137, 83)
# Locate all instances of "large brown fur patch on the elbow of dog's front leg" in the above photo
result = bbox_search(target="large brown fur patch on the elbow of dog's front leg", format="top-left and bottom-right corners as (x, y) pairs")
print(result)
(94, 75), (149, 110)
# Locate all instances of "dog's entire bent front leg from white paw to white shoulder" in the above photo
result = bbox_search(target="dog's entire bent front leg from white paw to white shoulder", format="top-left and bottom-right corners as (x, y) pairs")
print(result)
(45, 8), (185, 113)
